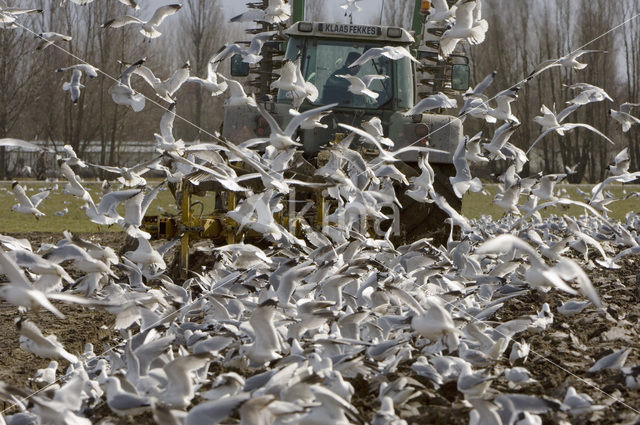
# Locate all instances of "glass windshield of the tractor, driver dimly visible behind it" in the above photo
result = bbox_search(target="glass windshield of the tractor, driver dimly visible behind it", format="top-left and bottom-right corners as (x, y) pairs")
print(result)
(278, 38), (413, 109)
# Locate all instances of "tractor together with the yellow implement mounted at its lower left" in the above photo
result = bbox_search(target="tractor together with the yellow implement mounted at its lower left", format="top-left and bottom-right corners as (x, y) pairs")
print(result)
(145, 0), (469, 270)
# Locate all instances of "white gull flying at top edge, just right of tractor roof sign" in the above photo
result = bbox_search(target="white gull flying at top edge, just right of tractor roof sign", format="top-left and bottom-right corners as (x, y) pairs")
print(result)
(440, 1), (489, 57)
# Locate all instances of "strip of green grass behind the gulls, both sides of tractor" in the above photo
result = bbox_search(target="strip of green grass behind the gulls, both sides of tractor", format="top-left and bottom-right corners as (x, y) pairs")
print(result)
(0, 181), (640, 233)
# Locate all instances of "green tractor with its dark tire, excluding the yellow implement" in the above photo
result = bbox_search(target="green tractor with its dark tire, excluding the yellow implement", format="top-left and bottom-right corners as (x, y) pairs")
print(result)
(222, 0), (469, 240)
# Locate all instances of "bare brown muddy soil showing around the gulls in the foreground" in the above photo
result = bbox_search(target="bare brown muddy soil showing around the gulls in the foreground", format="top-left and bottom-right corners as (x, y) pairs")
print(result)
(0, 233), (640, 425)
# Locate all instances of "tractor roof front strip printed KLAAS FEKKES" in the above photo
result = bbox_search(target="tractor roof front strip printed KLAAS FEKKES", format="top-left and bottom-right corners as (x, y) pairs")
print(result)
(285, 21), (415, 44)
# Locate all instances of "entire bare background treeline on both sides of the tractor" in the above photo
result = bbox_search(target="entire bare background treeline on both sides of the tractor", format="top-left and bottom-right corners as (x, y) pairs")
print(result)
(0, 0), (640, 181)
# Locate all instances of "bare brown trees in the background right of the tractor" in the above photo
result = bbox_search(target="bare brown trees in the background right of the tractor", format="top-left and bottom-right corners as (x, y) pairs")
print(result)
(465, 0), (640, 182)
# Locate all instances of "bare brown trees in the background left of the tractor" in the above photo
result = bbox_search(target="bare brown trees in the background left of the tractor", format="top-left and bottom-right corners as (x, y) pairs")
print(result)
(0, 0), (246, 178)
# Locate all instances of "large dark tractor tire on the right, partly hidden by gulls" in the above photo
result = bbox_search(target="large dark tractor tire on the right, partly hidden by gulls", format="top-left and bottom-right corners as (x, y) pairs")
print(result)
(394, 164), (462, 246)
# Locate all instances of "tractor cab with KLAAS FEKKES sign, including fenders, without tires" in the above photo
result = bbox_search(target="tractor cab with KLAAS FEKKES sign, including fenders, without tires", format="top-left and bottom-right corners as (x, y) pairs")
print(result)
(223, 21), (468, 163)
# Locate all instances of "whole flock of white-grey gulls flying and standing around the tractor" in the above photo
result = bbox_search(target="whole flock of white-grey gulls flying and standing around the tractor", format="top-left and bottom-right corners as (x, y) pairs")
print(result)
(0, 0), (640, 425)
